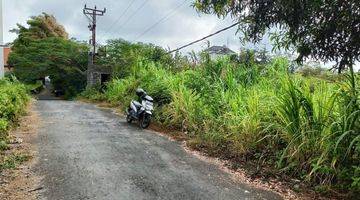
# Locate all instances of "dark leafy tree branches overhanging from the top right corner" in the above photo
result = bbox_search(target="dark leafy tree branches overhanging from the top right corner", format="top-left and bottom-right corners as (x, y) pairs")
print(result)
(194, 0), (360, 73)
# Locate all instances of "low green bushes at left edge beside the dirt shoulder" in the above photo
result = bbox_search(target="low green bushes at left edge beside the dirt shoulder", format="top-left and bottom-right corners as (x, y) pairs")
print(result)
(0, 79), (30, 171)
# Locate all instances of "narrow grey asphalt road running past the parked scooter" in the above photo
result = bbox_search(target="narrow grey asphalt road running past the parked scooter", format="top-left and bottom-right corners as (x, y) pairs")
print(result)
(36, 100), (281, 200)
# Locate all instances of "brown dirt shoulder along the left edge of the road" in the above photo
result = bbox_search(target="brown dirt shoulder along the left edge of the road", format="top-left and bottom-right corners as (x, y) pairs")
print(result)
(0, 101), (40, 200)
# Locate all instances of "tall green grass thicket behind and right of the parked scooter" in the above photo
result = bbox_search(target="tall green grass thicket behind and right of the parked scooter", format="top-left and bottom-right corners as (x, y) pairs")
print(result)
(83, 44), (360, 195)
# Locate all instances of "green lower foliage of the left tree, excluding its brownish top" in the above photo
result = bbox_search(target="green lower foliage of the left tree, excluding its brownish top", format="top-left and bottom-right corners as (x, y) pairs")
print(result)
(9, 37), (87, 96)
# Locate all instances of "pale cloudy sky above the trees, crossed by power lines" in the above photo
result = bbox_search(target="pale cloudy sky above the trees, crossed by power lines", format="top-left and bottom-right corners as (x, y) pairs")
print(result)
(3, 0), (271, 51)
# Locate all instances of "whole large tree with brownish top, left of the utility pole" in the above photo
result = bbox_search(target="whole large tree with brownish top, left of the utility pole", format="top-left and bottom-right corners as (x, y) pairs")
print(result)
(9, 13), (88, 96)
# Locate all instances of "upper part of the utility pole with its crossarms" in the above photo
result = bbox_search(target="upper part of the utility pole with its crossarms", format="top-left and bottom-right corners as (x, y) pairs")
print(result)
(83, 4), (106, 64)
